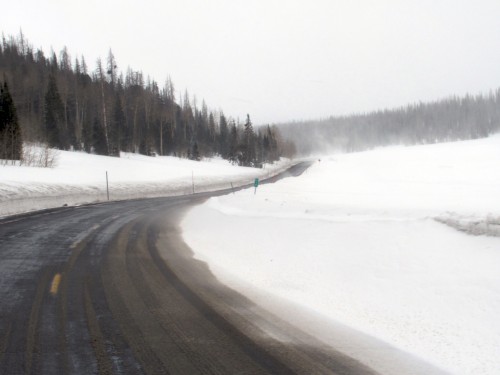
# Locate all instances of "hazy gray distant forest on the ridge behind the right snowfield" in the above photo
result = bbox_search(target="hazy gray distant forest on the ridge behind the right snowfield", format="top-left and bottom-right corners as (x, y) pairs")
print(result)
(277, 89), (500, 155)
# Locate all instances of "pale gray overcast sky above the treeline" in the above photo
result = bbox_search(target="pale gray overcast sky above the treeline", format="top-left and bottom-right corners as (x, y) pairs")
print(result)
(0, 0), (500, 124)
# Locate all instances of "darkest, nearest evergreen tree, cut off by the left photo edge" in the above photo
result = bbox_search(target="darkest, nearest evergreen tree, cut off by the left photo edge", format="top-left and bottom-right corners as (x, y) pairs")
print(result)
(0, 81), (23, 160)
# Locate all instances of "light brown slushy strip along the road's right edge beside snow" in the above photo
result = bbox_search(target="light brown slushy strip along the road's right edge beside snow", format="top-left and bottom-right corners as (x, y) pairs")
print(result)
(147, 206), (375, 375)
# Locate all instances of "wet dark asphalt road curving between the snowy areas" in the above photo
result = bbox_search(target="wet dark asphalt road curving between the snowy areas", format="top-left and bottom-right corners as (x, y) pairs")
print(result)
(0, 163), (373, 374)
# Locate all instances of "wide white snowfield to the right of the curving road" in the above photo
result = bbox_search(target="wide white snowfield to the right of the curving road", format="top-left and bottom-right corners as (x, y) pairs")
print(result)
(182, 135), (500, 375)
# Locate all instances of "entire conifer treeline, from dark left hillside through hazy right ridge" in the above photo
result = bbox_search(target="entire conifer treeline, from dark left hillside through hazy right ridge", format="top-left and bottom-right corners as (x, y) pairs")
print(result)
(0, 32), (500, 162)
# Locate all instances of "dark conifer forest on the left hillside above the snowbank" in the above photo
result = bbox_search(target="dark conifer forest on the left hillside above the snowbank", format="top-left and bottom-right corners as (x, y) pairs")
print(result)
(0, 32), (293, 166)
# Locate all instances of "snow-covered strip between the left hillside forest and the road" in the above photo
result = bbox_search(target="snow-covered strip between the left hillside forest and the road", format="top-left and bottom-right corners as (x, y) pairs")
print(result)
(0, 151), (288, 216)
